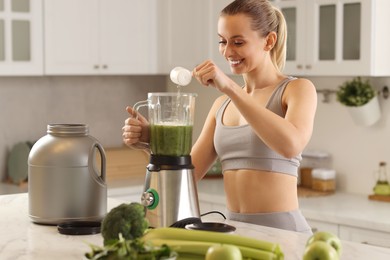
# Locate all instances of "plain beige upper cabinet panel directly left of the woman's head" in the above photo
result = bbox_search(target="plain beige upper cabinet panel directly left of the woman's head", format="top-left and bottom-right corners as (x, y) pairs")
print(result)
(158, 0), (212, 73)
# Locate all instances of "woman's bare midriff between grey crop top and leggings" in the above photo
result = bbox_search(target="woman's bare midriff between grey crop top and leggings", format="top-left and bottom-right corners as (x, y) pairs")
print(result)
(223, 170), (298, 213)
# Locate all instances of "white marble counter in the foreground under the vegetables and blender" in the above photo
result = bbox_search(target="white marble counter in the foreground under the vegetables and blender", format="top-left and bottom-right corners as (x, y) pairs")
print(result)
(0, 193), (390, 260)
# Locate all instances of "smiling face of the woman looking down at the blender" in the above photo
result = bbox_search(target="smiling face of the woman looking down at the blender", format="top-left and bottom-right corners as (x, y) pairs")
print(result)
(218, 14), (266, 74)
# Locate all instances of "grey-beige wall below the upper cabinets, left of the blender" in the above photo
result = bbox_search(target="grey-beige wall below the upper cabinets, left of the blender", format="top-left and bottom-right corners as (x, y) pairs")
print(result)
(0, 76), (166, 181)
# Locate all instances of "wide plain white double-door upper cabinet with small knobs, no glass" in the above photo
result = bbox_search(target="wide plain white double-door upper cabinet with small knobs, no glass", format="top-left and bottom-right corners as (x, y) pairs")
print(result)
(44, 0), (157, 75)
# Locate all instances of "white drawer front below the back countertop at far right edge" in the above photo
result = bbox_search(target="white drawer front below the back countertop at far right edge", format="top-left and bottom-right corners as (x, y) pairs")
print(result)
(339, 225), (390, 248)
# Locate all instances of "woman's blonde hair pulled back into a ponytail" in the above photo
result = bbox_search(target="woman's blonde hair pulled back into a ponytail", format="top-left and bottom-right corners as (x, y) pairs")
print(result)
(220, 0), (287, 71)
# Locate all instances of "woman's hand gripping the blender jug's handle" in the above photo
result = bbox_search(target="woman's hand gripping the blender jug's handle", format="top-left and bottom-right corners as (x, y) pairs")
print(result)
(122, 106), (150, 147)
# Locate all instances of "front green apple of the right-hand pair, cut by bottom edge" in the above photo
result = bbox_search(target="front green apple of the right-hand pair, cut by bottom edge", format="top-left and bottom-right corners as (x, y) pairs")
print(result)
(303, 240), (340, 260)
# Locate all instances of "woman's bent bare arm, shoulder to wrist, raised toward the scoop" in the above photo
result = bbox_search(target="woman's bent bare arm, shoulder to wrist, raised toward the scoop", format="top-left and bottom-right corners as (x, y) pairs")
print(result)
(226, 79), (317, 158)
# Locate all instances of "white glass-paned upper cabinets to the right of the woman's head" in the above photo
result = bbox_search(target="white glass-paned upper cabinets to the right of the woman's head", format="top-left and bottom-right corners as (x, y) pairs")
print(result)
(274, 0), (390, 76)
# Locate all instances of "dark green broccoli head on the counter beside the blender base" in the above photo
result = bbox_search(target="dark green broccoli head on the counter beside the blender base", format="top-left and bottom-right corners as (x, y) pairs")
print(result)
(101, 202), (149, 245)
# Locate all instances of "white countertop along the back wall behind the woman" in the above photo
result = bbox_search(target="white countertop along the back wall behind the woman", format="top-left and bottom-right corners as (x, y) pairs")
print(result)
(198, 179), (390, 235)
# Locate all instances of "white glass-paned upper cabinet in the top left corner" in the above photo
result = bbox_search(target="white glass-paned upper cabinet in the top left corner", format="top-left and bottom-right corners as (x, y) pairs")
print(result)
(0, 0), (43, 76)
